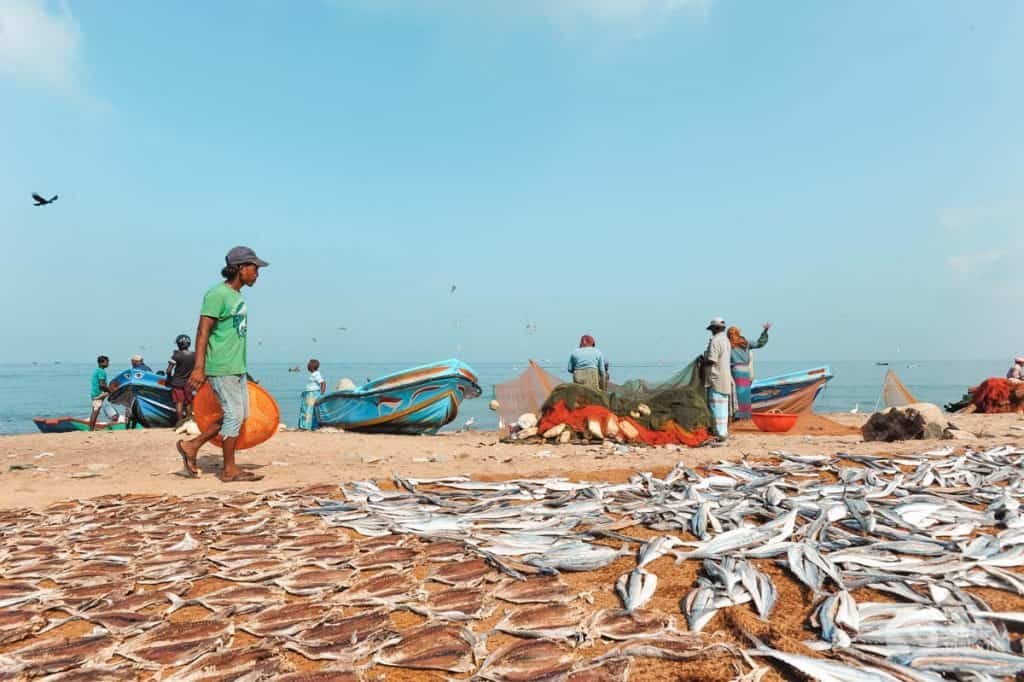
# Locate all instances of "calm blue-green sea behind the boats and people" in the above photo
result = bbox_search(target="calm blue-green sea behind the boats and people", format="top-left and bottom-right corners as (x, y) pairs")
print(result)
(0, 360), (1007, 433)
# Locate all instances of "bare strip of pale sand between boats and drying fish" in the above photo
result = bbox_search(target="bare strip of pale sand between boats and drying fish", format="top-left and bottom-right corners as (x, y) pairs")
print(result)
(0, 414), (1024, 509)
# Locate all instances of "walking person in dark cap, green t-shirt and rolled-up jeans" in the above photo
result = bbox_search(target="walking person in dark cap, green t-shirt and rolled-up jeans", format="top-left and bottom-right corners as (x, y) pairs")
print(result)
(177, 247), (269, 482)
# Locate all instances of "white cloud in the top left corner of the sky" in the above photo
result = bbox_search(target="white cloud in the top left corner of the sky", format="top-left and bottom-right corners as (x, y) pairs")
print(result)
(0, 0), (82, 93)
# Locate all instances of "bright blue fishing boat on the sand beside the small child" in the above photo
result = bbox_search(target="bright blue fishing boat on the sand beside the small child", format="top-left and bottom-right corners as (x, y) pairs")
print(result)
(315, 359), (480, 434)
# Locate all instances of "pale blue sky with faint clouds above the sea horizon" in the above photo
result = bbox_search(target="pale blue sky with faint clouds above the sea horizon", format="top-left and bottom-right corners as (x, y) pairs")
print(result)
(0, 0), (1024, 366)
